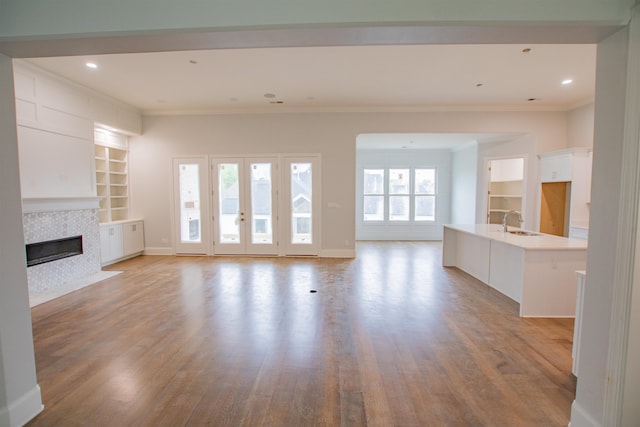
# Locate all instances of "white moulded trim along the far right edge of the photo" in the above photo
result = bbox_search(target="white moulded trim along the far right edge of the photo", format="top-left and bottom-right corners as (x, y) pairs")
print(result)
(603, 4), (640, 427)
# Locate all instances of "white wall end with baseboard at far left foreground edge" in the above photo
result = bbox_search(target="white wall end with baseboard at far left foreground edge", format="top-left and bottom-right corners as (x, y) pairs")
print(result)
(0, 55), (43, 426)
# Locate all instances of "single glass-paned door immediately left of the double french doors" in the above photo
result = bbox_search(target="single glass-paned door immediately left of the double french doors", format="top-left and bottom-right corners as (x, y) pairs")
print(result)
(173, 156), (209, 255)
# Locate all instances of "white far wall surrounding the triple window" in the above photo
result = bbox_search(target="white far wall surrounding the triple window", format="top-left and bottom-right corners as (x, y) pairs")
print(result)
(355, 149), (451, 240)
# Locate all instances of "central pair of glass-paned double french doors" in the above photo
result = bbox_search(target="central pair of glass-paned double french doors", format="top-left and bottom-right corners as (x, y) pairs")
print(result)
(211, 157), (278, 255)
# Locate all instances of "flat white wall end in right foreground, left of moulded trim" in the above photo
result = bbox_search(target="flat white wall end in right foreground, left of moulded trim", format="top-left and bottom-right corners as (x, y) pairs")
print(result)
(571, 20), (635, 427)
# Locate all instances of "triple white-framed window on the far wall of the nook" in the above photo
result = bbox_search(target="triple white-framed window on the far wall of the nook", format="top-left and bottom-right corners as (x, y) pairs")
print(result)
(362, 168), (436, 222)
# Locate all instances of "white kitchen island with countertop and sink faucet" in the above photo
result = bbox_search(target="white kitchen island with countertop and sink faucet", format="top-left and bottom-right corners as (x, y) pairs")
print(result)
(442, 224), (587, 317)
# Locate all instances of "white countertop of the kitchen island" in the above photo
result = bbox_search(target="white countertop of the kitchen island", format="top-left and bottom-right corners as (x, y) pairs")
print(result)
(445, 224), (587, 250)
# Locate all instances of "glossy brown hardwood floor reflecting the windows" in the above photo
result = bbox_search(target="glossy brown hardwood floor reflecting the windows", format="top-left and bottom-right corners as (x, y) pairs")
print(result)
(29, 242), (575, 427)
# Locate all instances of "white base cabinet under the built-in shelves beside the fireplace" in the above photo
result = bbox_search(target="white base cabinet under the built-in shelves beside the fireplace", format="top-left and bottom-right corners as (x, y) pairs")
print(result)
(100, 220), (144, 266)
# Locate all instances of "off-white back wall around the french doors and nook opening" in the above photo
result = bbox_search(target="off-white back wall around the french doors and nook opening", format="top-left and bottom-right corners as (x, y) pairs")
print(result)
(129, 112), (566, 252)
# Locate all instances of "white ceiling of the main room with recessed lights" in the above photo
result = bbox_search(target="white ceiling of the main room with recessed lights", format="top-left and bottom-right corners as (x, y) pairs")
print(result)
(28, 44), (596, 114)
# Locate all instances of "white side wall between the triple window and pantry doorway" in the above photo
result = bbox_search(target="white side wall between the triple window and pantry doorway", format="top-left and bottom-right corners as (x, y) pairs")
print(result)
(451, 143), (478, 224)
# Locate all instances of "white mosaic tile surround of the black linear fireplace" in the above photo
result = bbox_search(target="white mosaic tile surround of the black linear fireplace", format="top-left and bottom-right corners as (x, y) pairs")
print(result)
(23, 209), (102, 296)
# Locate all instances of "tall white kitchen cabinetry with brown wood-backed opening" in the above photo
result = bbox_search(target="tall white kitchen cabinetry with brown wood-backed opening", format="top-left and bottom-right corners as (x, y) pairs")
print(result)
(539, 148), (592, 239)
